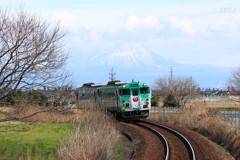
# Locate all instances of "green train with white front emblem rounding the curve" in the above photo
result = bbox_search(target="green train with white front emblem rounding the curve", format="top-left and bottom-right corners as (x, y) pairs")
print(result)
(77, 80), (151, 120)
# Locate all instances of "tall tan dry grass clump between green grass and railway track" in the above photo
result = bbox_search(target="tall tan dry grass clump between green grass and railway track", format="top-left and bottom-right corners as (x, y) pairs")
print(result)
(58, 110), (120, 160)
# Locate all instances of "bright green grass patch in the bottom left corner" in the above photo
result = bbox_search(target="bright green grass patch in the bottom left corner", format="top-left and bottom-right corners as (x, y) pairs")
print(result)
(0, 122), (74, 160)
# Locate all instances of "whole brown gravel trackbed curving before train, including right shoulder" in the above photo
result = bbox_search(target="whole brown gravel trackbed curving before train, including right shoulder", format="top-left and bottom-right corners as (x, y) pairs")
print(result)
(119, 119), (234, 160)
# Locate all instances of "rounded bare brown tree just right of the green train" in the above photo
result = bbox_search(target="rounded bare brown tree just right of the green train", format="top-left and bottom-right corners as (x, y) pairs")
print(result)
(154, 75), (200, 104)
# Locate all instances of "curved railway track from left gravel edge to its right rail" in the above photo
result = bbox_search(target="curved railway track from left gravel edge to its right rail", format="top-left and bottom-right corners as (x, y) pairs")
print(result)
(120, 120), (196, 160)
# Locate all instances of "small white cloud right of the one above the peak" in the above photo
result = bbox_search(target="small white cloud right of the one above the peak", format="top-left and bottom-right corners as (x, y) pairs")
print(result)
(169, 17), (195, 36)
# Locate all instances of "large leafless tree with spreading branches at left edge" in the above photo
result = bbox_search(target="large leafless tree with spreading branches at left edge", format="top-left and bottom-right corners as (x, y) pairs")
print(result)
(0, 8), (68, 101)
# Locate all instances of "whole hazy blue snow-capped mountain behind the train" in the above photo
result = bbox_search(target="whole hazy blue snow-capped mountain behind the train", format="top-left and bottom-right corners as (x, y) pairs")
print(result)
(69, 42), (232, 88)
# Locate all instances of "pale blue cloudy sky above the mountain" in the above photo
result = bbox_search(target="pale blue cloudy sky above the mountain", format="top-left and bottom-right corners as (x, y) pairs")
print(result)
(0, 0), (240, 67)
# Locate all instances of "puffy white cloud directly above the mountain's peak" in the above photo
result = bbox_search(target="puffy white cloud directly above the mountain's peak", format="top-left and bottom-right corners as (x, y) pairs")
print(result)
(125, 15), (158, 30)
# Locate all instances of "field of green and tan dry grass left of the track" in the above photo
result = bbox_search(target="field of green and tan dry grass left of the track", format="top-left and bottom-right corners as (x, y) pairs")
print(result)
(0, 106), (123, 160)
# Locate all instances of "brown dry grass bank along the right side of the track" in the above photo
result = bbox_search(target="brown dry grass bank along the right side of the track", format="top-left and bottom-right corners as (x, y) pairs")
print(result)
(150, 103), (240, 158)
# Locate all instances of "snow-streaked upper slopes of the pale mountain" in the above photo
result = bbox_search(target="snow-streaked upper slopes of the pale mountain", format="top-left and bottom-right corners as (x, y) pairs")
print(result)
(76, 42), (174, 67)
